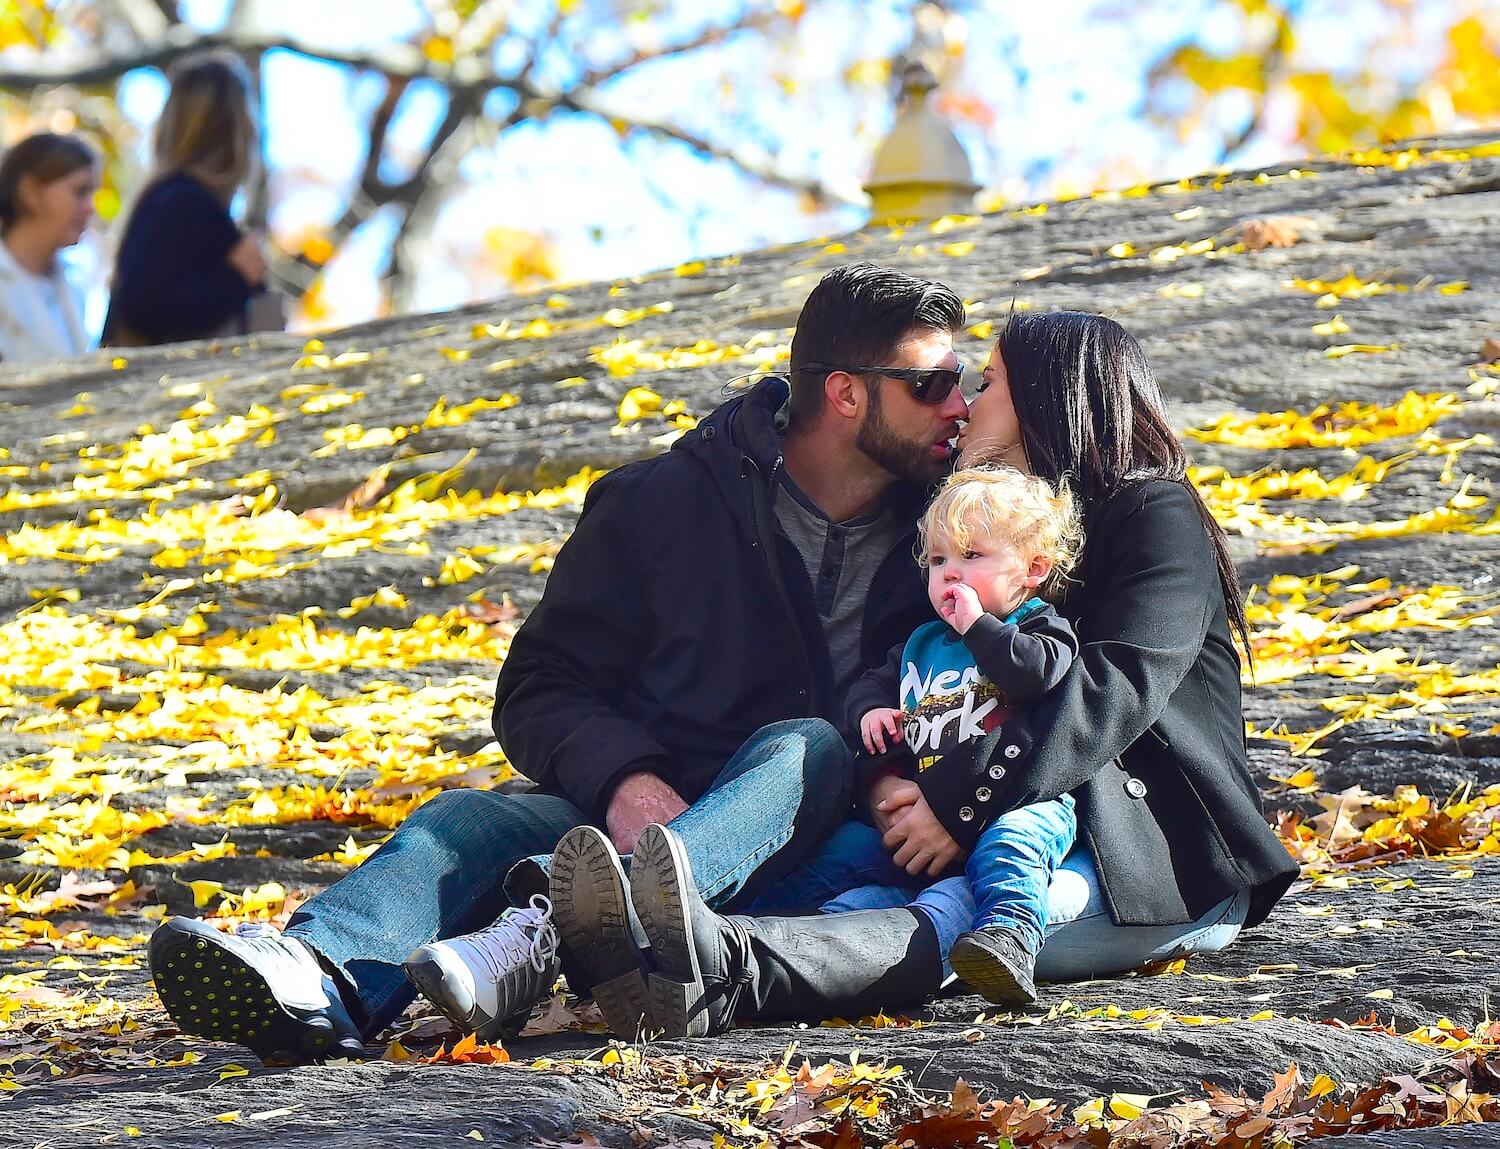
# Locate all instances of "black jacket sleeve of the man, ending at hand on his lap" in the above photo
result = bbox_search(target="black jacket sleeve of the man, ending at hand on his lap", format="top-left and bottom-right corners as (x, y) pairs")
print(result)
(495, 468), (674, 821)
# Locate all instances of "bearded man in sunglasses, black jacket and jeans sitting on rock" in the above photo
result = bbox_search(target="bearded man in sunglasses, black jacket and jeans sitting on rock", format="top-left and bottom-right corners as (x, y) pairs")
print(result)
(150, 264), (968, 1061)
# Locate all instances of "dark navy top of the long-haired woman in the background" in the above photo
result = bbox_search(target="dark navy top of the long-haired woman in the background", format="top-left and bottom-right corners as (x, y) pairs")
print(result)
(113, 180), (254, 342)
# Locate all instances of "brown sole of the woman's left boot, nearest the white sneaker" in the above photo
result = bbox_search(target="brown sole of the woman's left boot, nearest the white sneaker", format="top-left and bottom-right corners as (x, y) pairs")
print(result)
(551, 827), (654, 1041)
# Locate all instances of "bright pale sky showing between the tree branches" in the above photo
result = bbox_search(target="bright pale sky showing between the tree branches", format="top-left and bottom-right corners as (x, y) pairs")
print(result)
(32, 0), (1488, 333)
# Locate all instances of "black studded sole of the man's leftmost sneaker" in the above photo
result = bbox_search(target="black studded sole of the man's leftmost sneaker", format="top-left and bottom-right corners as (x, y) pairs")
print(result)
(147, 920), (336, 1061)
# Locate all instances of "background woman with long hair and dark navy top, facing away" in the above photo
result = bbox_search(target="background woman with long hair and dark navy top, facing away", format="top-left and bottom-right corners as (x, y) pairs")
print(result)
(104, 56), (266, 347)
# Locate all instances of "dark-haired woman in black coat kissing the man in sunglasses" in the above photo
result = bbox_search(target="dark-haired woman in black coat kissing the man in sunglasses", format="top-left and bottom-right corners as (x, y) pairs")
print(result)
(560, 312), (1298, 1037)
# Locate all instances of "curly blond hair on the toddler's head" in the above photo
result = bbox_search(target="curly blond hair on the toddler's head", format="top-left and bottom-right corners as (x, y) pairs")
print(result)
(917, 465), (1083, 599)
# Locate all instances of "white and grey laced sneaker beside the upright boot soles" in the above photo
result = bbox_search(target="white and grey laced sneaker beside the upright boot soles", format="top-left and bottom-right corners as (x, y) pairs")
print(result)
(404, 894), (560, 1043)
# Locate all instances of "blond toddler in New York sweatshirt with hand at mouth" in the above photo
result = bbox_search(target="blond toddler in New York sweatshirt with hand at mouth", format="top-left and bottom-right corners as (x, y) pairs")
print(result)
(846, 467), (1083, 1005)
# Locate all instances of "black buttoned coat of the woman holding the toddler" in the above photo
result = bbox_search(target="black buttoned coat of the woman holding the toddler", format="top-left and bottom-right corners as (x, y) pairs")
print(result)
(918, 479), (1298, 926)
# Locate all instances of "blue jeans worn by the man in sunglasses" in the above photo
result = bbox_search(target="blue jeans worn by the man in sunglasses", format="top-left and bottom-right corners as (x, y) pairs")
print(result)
(287, 719), (854, 1038)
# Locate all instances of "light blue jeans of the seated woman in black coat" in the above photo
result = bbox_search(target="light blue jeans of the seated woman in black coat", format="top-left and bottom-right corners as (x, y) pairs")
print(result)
(750, 822), (1250, 981)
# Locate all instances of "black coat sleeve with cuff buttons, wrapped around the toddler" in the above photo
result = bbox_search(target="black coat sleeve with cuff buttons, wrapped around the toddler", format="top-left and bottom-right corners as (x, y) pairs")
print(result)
(918, 480), (1221, 848)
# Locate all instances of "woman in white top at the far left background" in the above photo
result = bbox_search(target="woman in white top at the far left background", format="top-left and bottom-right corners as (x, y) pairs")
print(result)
(0, 132), (99, 363)
